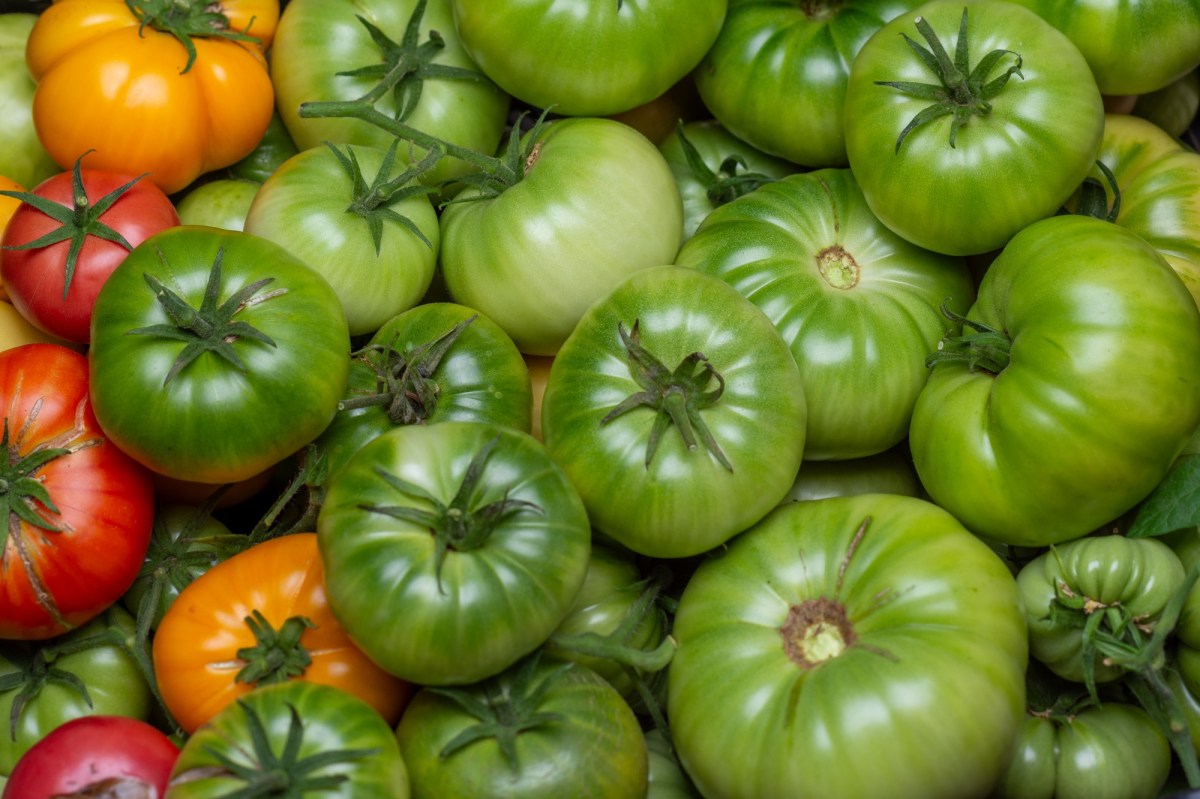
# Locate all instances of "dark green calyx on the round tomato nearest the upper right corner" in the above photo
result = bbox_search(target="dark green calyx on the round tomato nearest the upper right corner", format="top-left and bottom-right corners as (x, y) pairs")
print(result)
(875, 7), (1025, 152)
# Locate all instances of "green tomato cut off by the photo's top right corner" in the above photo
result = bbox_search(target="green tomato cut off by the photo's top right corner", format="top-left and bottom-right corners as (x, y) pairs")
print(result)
(1014, 0), (1200, 95)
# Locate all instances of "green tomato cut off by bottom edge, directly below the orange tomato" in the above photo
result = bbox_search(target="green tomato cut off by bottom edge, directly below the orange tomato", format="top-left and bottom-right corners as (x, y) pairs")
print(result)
(163, 680), (410, 799)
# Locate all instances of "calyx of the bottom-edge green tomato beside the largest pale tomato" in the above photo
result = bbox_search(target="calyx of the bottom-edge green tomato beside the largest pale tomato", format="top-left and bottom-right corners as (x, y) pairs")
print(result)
(426, 653), (574, 771)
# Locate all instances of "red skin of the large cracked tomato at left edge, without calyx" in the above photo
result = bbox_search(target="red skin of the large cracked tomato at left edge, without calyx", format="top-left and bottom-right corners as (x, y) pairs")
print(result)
(0, 343), (154, 639)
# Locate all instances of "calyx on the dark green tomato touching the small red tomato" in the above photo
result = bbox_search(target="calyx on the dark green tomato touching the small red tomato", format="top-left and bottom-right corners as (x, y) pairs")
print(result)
(128, 247), (287, 386)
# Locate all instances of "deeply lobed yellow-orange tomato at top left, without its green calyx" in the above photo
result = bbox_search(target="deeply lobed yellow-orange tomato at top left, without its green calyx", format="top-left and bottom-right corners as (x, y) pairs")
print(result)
(25, 0), (280, 194)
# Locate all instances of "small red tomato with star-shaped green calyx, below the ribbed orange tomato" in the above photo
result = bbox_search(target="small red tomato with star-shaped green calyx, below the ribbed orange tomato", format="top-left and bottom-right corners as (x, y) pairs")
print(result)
(0, 155), (180, 343)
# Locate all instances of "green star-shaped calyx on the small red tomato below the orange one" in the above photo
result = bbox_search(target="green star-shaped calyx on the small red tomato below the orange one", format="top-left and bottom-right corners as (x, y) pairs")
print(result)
(0, 150), (149, 297)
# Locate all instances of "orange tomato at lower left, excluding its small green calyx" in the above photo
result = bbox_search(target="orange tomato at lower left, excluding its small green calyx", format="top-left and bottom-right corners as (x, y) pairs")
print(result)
(152, 533), (414, 733)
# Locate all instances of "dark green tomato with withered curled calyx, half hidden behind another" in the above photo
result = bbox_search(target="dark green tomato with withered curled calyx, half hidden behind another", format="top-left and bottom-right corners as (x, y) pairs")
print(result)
(316, 302), (533, 474)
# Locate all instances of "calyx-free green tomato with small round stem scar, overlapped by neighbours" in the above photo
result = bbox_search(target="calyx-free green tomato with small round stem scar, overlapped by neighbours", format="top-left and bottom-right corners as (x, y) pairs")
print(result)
(676, 169), (974, 461)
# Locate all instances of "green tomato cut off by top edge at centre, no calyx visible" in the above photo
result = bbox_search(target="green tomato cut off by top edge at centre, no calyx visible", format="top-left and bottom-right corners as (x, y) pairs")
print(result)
(451, 0), (727, 116)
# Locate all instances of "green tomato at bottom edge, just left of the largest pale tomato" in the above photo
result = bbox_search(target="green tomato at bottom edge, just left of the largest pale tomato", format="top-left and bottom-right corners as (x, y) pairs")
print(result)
(396, 657), (648, 799)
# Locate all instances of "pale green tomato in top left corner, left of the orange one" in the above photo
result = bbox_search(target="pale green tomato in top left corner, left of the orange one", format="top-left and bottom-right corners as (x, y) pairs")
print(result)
(0, 12), (62, 188)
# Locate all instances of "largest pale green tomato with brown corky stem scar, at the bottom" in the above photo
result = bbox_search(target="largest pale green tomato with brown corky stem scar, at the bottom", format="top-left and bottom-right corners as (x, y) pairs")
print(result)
(667, 494), (1027, 799)
